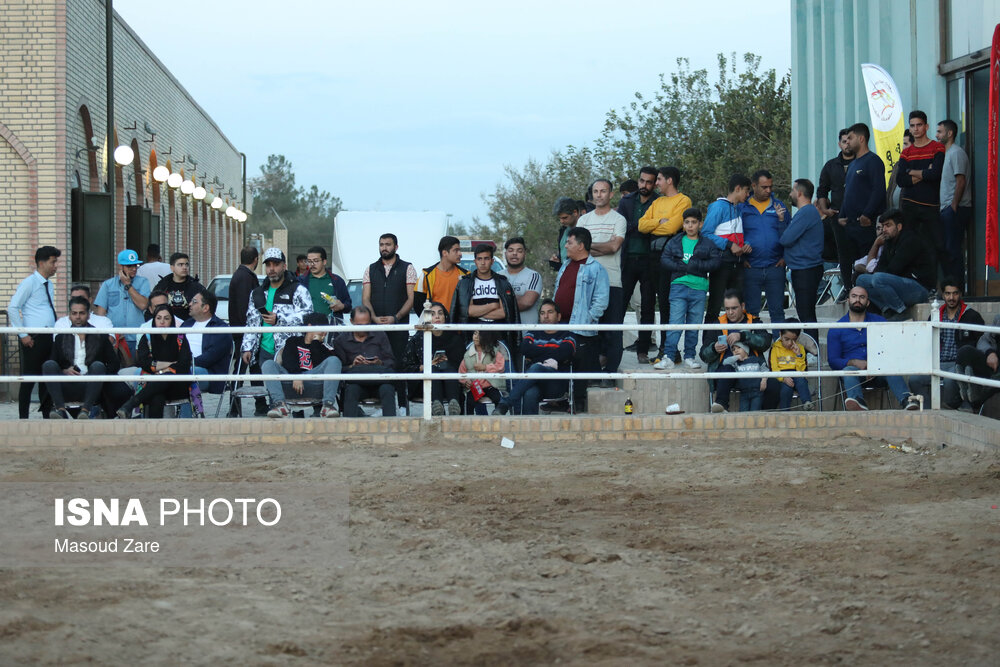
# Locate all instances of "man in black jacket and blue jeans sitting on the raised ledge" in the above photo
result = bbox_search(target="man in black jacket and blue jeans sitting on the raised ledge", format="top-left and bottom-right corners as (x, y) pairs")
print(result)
(857, 208), (937, 321)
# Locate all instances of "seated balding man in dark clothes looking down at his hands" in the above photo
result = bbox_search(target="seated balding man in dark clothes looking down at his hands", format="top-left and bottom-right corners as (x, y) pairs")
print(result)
(334, 306), (396, 417)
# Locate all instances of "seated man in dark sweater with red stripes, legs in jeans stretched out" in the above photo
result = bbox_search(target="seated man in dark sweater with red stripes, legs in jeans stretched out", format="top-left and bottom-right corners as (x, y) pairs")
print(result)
(497, 299), (576, 415)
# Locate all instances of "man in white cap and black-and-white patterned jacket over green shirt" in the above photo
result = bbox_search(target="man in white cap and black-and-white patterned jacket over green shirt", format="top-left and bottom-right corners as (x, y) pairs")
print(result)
(241, 248), (312, 380)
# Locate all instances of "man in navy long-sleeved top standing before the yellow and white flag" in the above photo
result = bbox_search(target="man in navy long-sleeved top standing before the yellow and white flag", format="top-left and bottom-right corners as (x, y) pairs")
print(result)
(834, 123), (885, 299)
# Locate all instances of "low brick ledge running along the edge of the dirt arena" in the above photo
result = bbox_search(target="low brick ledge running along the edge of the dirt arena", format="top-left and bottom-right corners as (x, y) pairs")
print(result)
(0, 410), (1000, 451)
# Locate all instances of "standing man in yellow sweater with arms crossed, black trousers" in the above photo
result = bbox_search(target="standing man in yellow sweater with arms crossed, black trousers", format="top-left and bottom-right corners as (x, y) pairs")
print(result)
(638, 167), (691, 363)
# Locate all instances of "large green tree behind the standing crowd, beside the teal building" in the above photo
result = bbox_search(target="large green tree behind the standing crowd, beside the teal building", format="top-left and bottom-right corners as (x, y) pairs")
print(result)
(472, 53), (791, 287)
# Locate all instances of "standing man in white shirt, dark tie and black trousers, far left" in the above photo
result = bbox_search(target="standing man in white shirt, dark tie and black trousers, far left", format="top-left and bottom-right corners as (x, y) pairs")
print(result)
(7, 245), (62, 419)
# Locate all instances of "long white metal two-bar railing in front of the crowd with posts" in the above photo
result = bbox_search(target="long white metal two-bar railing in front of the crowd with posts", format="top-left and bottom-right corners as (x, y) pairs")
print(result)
(0, 318), (1000, 420)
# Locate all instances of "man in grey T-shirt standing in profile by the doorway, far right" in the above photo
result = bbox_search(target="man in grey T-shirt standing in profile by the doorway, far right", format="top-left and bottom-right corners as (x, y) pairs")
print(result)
(937, 120), (972, 288)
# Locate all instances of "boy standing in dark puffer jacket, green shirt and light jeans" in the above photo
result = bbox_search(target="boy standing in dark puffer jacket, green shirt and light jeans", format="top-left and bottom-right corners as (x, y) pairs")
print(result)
(653, 207), (722, 370)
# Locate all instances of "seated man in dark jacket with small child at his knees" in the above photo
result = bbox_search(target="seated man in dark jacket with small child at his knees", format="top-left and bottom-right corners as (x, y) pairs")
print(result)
(698, 289), (771, 412)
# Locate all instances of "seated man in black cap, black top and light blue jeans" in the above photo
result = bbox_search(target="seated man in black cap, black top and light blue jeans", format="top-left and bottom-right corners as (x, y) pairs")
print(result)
(262, 312), (342, 419)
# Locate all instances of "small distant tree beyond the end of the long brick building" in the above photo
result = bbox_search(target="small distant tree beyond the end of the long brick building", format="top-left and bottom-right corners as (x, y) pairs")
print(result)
(247, 155), (343, 256)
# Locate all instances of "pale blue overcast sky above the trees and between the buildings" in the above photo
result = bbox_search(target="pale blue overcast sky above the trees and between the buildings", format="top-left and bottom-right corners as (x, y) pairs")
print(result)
(115, 0), (791, 227)
